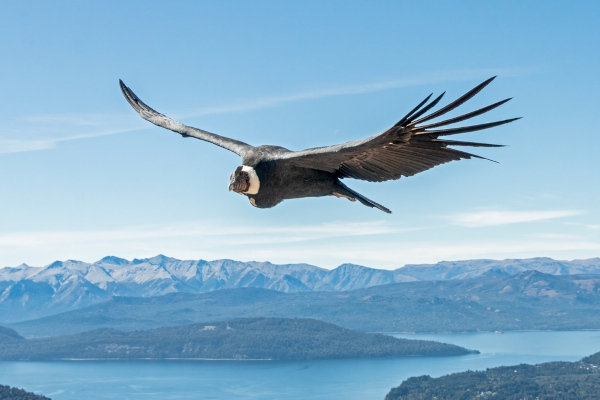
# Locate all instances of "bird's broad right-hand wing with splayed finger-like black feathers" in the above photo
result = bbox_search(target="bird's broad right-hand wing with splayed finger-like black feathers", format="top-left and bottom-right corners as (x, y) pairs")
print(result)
(274, 77), (519, 182)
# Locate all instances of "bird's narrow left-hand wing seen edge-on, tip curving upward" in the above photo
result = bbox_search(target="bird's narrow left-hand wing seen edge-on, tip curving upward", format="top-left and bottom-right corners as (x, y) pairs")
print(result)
(119, 79), (252, 157)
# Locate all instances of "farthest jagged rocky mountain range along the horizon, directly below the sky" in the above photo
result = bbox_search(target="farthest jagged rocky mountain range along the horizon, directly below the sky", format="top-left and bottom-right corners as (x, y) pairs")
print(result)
(0, 255), (600, 322)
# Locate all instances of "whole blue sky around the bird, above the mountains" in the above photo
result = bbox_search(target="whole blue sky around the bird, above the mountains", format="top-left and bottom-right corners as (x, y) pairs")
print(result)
(0, 1), (600, 269)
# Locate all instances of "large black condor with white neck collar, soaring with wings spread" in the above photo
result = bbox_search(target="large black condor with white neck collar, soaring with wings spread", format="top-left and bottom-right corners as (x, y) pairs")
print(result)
(119, 77), (519, 213)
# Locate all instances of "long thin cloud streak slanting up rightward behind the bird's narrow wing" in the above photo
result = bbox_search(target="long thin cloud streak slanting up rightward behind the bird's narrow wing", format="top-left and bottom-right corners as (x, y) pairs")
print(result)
(0, 68), (533, 153)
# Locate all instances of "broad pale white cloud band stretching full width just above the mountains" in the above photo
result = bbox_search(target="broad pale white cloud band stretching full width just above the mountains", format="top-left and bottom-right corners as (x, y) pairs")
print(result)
(0, 220), (600, 269)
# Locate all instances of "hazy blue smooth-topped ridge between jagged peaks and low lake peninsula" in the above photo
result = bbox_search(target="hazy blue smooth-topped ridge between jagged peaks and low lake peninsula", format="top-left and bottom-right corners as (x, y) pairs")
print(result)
(12, 271), (600, 337)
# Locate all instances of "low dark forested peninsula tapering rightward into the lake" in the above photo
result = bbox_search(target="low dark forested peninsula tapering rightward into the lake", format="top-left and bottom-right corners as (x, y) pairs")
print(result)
(0, 318), (474, 360)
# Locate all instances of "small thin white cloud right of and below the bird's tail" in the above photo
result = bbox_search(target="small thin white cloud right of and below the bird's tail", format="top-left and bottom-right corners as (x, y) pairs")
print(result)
(448, 210), (582, 228)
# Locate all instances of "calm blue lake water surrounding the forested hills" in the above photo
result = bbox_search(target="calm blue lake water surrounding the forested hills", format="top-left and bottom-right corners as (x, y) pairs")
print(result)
(0, 331), (600, 400)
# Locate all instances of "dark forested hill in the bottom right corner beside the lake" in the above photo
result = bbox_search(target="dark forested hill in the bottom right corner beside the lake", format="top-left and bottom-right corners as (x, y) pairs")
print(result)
(385, 353), (600, 400)
